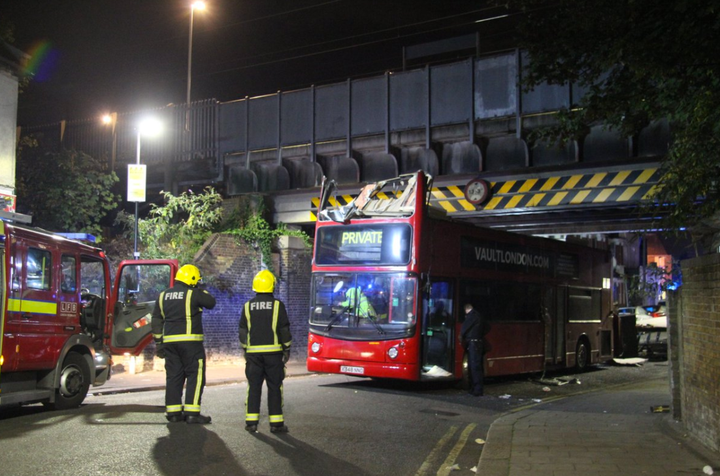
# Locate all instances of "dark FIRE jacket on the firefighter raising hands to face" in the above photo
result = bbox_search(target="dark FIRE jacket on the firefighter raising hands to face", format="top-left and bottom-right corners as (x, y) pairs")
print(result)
(152, 281), (215, 344)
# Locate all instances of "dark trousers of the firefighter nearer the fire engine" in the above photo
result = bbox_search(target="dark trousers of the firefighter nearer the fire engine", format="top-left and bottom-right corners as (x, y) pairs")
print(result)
(164, 342), (206, 413)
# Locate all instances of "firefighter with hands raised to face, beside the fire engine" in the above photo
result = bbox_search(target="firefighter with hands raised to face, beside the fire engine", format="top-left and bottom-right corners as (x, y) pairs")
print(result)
(152, 264), (215, 424)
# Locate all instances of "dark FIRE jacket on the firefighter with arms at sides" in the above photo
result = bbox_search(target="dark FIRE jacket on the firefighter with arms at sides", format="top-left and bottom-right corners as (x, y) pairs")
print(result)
(239, 293), (292, 354)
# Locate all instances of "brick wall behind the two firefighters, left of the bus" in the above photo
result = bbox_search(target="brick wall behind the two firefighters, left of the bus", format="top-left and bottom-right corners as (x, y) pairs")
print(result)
(195, 234), (311, 364)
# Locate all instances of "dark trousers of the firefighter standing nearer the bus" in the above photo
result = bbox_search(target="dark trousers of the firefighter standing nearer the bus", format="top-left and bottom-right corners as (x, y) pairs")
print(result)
(245, 353), (285, 426)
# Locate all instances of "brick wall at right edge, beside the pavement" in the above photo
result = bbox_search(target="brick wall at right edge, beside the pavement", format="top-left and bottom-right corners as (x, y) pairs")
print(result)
(670, 254), (720, 451)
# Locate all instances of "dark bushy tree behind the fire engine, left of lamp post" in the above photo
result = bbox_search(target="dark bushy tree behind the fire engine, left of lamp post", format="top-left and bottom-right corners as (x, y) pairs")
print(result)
(16, 142), (119, 237)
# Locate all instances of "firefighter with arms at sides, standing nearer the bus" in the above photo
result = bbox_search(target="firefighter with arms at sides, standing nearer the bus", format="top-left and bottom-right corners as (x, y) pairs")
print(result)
(239, 270), (291, 433)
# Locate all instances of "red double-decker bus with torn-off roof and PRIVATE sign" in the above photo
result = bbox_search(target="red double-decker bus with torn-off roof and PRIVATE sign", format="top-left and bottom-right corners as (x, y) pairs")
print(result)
(307, 172), (613, 380)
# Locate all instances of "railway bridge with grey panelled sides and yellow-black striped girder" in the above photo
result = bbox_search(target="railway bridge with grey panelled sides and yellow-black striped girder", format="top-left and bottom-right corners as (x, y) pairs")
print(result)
(22, 50), (670, 234)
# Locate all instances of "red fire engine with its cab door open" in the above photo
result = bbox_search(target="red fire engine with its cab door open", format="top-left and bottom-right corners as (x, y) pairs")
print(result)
(0, 212), (178, 409)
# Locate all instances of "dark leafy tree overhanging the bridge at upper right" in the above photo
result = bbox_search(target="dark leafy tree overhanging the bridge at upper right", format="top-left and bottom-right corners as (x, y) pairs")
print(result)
(507, 0), (720, 245)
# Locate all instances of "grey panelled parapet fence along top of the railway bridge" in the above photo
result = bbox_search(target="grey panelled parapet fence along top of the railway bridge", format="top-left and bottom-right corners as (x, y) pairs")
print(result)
(22, 50), (669, 196)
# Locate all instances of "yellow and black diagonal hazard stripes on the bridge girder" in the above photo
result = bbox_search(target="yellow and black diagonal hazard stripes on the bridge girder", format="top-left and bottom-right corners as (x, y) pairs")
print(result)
(310, 167), (660, 221)
